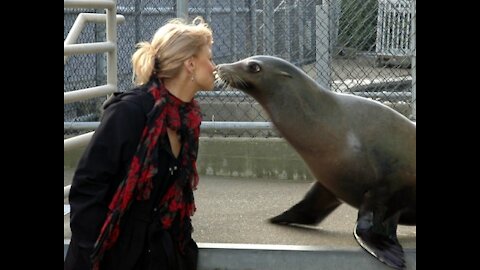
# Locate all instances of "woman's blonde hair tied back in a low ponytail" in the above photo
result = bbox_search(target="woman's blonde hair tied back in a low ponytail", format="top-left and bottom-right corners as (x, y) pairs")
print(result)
(132, 17), (213, 85)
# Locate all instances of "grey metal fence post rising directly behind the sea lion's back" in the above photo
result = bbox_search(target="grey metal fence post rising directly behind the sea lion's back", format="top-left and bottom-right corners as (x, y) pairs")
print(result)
(315, 0), (330, 89)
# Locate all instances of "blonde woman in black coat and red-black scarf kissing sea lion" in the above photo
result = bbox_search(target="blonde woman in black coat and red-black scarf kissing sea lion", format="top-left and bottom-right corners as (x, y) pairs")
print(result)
(64, 18), (215, 270)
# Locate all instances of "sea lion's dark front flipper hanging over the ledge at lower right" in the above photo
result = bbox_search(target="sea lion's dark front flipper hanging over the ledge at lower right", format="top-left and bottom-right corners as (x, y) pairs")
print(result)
(353, 191), (405, 269)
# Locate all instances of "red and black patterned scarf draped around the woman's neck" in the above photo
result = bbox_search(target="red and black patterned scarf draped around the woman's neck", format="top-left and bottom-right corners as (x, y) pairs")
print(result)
(92, 80), (202, 269)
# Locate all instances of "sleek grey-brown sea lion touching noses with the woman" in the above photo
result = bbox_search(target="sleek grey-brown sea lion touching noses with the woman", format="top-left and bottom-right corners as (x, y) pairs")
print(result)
(217, 55), (416, 269)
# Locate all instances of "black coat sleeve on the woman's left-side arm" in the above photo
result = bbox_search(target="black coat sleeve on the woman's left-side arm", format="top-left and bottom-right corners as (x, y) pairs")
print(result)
(69, 100), (146, 249)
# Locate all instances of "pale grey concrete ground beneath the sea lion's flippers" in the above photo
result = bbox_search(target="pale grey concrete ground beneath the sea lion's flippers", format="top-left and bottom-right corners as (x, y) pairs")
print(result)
(64, 173), (416, 248)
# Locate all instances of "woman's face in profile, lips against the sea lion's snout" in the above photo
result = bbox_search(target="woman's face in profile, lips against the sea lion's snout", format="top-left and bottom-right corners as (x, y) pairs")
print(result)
(194, 45), (215, 91)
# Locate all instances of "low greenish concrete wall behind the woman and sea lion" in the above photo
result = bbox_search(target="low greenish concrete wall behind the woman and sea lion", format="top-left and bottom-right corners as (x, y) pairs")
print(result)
(64, 137), (313, 180)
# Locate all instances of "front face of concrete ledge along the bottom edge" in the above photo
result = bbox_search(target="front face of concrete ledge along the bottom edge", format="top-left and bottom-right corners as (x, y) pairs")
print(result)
(64, 240), (417, 270)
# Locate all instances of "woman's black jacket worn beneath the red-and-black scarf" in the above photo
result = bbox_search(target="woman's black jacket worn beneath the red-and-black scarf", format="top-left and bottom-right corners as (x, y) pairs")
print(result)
(64, 87), (196, 270)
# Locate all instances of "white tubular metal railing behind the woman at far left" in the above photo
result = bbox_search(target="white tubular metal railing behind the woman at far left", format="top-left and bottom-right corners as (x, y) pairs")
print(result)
(63, 0), (125, 198)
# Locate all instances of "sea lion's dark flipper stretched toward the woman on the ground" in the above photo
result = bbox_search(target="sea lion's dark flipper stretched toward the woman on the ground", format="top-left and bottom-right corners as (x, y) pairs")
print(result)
(270, 182), (341, 225)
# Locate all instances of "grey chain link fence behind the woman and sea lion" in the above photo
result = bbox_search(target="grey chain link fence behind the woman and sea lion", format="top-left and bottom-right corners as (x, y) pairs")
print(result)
(64, 0), (416, 137)
